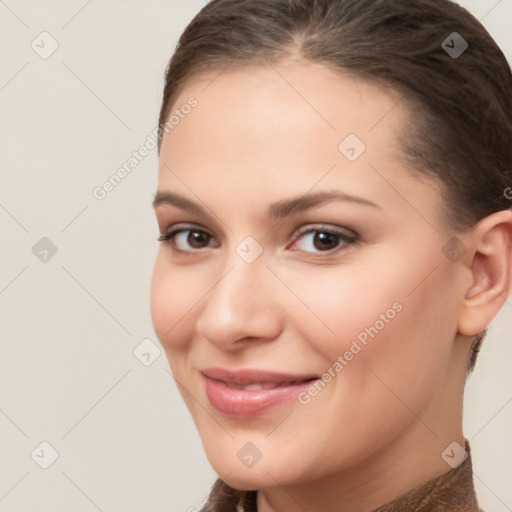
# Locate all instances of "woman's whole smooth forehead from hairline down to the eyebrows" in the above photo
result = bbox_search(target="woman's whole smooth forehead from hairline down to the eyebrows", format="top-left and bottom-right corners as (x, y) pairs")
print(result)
(159, 62), (440, 226)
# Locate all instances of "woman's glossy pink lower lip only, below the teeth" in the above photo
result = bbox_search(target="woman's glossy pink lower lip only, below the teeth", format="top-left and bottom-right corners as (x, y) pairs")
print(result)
(203, 375), (316, 419)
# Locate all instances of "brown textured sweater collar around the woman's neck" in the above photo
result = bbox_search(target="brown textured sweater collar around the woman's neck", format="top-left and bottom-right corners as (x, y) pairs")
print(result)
(238, 440), (483, 512)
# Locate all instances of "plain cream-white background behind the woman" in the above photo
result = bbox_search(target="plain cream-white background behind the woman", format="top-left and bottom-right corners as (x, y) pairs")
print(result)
(0, 0), (512, 512)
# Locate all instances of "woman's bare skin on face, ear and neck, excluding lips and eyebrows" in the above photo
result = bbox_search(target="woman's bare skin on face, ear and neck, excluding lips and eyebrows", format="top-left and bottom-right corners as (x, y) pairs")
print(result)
(151, 60), (512, 512)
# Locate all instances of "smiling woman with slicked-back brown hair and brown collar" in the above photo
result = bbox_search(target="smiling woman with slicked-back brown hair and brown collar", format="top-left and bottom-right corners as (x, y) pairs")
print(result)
(151, 0), (512, 512)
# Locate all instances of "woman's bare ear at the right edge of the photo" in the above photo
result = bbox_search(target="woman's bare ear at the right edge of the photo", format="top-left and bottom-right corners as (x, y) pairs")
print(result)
(458, 210), (512, 336)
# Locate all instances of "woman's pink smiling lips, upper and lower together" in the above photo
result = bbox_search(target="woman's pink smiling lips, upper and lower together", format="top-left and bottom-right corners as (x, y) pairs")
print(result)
(201, 367), (318, 419)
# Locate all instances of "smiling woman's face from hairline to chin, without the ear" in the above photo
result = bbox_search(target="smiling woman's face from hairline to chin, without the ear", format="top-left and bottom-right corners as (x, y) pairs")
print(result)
(151, 61), (461, 489)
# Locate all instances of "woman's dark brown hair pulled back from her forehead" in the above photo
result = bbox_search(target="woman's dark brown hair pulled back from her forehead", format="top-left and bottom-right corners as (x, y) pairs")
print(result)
(158, 0), (512, 512)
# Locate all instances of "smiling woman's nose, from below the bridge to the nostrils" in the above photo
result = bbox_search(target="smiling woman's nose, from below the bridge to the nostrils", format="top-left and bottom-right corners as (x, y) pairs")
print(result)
(196, 247), (283, 350)
